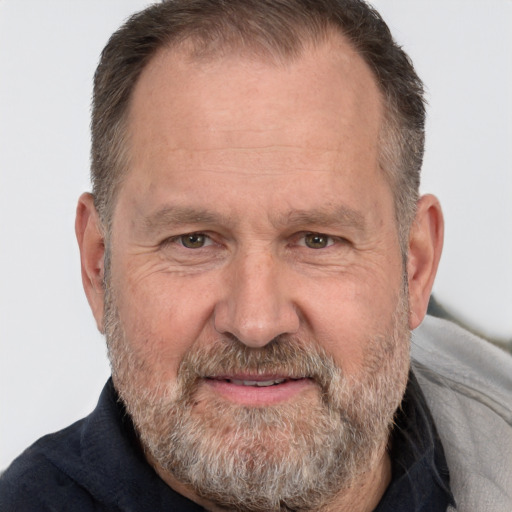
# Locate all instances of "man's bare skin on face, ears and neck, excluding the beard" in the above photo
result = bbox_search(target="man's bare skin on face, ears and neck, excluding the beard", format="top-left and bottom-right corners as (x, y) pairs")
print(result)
(76, 36), (443, 511)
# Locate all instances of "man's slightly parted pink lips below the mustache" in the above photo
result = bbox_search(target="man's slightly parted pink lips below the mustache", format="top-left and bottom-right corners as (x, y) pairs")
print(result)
(203, 379), (315, 406)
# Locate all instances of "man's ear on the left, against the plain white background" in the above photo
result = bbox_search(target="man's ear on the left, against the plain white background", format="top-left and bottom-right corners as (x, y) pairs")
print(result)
(75, 193), (105, 332)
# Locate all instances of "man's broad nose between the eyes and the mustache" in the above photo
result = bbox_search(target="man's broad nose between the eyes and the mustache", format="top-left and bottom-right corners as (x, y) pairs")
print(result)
(214, 249), (300, 348)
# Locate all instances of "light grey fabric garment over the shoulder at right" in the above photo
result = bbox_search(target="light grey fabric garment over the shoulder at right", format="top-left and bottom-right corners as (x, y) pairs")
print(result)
(411, 317), (512, 512)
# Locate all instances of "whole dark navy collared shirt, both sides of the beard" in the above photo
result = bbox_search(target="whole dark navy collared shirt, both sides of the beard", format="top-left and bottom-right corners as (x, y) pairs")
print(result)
(0, 376), (453, 512)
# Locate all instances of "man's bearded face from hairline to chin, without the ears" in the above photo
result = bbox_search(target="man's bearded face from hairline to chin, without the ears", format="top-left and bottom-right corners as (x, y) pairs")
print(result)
(106, 39), (408, 510)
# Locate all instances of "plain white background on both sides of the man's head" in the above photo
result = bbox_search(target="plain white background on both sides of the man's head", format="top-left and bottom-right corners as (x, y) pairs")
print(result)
(0, 0), (512, 469)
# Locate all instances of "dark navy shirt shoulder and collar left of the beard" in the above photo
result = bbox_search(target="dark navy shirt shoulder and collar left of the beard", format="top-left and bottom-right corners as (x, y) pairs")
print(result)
(0, 379), (202, 512)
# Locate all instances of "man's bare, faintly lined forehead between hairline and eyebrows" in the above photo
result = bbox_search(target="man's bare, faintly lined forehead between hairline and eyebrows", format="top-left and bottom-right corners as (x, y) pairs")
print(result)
(120, 36), (383, 227)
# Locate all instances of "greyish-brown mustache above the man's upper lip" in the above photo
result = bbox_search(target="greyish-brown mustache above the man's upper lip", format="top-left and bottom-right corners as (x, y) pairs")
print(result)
(178, 335), (341, 393)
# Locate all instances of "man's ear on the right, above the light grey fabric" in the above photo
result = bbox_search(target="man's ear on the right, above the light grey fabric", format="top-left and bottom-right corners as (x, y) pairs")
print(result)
(407, 194), (444, 329)
